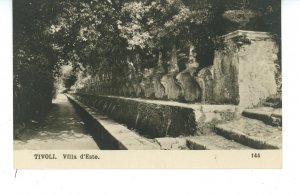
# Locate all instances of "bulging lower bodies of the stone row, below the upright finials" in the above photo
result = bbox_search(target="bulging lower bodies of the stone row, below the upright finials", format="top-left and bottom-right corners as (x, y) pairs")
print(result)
(83, 67), (213, 103)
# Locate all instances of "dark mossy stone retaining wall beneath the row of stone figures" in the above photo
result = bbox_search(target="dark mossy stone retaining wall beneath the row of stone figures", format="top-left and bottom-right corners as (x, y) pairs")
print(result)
(71, 93), (238, 138)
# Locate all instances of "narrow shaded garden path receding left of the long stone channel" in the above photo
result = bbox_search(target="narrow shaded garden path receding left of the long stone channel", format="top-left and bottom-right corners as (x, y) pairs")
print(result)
(14, 94), (99, 150)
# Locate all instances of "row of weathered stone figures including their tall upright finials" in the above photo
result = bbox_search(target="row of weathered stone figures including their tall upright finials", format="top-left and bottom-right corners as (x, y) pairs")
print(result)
(78, 45), (213, 103)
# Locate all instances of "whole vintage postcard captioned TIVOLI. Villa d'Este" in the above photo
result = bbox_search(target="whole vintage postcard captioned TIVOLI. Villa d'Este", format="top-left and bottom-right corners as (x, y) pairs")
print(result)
(13, 0), (282, 169)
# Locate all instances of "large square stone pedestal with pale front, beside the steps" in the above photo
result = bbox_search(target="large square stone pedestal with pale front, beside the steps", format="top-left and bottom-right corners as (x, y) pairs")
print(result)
(212, 30), (278, 107)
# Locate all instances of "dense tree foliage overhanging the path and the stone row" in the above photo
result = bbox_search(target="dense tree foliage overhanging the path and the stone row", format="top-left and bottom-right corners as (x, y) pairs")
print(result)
(13, 0), (280, 121)
